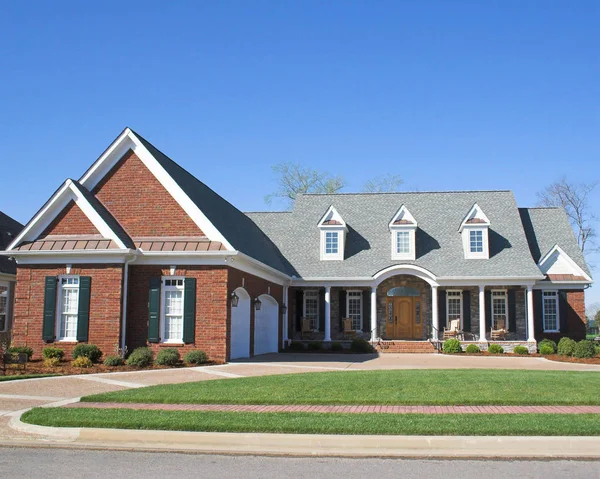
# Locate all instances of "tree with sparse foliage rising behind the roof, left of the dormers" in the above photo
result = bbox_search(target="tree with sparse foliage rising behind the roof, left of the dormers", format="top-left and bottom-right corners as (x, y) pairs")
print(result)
(265, 162), (346, 207)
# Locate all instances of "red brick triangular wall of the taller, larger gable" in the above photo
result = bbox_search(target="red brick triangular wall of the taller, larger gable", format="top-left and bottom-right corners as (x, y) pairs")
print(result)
(93, 151), (203, 236)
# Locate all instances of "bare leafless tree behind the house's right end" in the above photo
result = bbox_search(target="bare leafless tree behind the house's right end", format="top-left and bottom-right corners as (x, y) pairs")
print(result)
(537, 176), (598, 252)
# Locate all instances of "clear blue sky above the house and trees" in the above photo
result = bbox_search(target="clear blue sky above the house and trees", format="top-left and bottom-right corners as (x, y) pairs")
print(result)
(0, 0), (600, 301)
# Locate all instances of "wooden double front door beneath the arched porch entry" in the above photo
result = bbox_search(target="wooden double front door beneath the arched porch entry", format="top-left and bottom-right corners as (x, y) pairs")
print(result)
(386, 296), (423, 339)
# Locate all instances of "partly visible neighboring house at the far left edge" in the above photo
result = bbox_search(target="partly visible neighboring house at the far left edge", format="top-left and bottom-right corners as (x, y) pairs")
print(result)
(0, 211), (23, 351)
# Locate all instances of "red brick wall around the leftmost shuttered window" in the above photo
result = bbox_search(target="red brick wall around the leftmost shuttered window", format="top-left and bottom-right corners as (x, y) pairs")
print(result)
(12, 264), (123, 359)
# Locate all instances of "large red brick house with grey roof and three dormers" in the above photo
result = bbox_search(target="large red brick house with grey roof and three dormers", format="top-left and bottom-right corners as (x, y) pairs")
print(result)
(4, 128), (592, 361)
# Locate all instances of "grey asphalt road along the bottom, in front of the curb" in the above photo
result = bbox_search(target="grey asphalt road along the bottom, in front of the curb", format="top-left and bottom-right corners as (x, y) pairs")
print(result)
(0, 448), (600, 479)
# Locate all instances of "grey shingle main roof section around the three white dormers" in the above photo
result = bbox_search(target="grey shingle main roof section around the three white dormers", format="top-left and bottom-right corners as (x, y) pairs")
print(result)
(248, 191), (543, 279)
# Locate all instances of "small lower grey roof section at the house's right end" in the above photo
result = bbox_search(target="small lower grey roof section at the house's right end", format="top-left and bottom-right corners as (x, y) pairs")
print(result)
(519, 208), (591, 276)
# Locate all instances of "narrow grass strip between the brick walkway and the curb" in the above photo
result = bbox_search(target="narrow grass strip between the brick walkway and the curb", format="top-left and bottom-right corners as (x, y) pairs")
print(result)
(22, 408), (600, 436)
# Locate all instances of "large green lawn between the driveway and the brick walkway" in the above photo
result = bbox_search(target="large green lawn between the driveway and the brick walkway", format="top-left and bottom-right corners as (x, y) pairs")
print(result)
(82, 369), (600, 405)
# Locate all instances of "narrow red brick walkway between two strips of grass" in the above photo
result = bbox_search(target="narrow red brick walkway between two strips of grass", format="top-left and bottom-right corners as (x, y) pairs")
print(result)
(63, 402), (600, 414)
